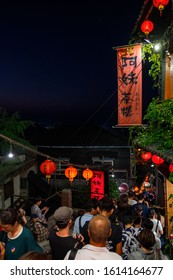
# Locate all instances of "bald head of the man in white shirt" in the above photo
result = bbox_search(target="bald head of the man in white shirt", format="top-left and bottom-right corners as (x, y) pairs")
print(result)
(88, 214), (111, 247)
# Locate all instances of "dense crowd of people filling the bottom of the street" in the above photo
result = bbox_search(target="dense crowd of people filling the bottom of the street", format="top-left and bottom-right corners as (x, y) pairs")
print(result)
(0, 191), (168, 260)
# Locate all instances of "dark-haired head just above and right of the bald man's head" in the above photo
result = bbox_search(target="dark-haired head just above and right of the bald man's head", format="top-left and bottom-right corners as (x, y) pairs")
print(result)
(98, 197), (114, 217)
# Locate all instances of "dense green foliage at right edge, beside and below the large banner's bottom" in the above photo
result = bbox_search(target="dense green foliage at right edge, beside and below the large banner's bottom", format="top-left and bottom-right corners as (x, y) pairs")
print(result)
(129, 98), (173, 151)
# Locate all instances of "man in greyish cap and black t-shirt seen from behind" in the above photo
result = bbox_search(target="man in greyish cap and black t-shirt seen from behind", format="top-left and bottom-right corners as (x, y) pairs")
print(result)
(49, 206), (83, 260)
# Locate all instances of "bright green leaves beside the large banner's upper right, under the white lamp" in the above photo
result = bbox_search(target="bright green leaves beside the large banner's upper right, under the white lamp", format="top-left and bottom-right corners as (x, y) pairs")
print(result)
(142, 44), (161, 88)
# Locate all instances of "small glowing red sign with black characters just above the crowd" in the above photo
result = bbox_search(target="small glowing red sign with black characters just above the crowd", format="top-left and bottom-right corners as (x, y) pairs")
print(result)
(91, 171), (104, 200)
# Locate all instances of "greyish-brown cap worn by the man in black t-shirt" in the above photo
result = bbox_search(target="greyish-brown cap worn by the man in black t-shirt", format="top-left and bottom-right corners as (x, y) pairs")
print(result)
(54, 206), (73, 223)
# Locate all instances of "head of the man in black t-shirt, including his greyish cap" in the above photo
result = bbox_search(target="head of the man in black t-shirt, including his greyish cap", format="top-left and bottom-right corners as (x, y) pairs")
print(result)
(54, 206), (73, 229)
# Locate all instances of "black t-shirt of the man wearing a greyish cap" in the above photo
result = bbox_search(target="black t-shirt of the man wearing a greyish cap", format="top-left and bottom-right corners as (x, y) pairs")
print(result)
(49, 229), (81, 260)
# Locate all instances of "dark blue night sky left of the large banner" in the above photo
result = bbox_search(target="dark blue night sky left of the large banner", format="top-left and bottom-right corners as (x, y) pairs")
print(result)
(0, 0), (152, 125)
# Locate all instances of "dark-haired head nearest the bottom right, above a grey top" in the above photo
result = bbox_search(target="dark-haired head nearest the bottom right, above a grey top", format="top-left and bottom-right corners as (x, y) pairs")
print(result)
(137, 228), (156, 250)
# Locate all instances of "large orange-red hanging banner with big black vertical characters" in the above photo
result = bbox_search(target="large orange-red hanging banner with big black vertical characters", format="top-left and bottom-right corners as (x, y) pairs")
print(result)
(117, 45), (142, 126)
